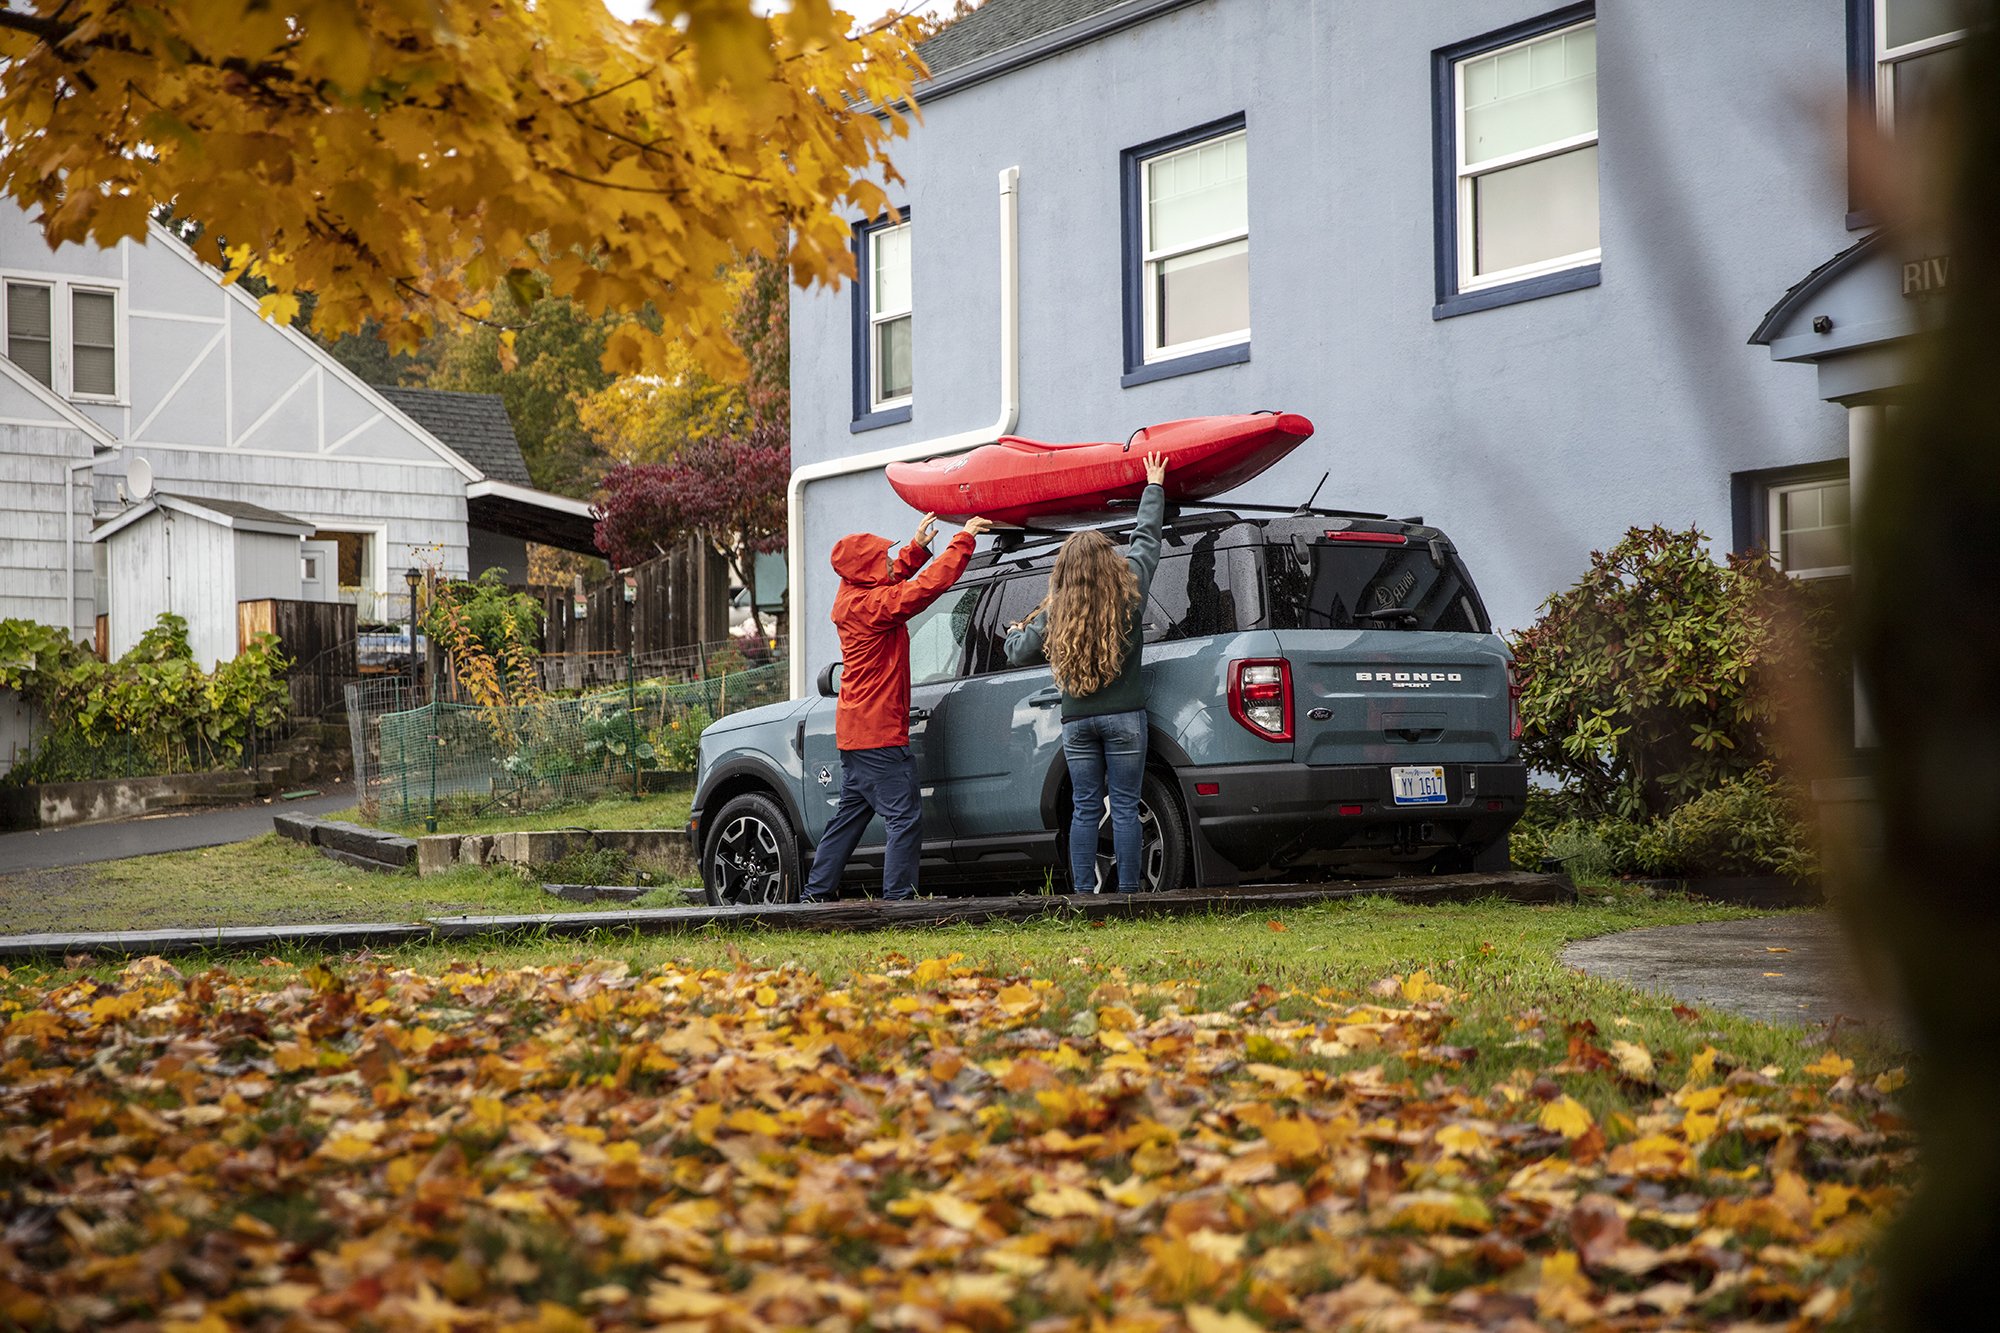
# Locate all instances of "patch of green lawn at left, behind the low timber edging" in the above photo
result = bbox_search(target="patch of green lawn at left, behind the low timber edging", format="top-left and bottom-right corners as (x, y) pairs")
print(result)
(0, 833), (696, 935)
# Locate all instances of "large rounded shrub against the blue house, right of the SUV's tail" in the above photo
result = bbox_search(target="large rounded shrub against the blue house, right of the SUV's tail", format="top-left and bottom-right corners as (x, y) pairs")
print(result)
(1514, 526), (1834, 819)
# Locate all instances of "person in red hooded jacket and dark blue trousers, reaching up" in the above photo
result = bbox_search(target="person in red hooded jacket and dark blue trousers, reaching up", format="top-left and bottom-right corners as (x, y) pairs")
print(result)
(804, 514), (992, 903)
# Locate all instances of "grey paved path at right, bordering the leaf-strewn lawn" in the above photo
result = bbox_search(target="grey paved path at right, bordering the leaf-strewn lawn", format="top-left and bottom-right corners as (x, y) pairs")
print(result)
(1562, 911), (1886, 1025)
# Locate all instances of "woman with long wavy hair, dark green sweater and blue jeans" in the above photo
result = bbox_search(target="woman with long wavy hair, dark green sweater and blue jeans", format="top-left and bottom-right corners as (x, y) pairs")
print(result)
(1006, 454), (1166, 893)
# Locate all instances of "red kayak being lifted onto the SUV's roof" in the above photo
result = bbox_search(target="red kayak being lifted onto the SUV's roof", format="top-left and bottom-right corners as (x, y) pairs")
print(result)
(888, 412), (1312, 524)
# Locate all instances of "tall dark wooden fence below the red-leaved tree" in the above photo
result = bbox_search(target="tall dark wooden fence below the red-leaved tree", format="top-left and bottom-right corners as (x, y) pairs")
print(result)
(538, 540), (730, 691)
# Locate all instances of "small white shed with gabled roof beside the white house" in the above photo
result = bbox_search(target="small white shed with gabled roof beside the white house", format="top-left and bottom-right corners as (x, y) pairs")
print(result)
(90, 492), (314, 669)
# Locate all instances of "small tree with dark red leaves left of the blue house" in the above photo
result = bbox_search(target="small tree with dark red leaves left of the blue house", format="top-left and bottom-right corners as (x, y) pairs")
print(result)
(596, 422), (792, 636)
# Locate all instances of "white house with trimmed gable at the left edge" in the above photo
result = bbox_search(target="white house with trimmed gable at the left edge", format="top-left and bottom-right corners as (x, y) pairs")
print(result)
(0, 204), (594, 650)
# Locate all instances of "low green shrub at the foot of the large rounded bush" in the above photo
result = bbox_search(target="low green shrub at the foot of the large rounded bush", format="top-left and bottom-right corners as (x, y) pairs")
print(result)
(1634, 767), (1820, 881)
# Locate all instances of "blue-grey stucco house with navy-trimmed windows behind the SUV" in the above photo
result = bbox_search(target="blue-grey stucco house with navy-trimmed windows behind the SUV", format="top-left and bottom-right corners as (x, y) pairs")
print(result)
(792, 0), (1962, 704)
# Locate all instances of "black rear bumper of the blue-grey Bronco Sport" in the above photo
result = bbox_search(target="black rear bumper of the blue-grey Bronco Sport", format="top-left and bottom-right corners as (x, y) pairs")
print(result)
(1176, 763), (1528, 875)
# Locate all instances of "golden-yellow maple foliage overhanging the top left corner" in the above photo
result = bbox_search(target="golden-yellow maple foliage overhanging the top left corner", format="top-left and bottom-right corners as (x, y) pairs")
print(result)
(0, 0), (918, 374)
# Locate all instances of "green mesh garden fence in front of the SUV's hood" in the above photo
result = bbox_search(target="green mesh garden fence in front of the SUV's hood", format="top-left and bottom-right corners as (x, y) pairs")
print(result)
(348, 662), (788, 825)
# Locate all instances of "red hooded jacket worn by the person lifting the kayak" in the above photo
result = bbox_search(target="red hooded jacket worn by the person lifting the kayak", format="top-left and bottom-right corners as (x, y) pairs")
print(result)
(834, 532), (972, 751)
